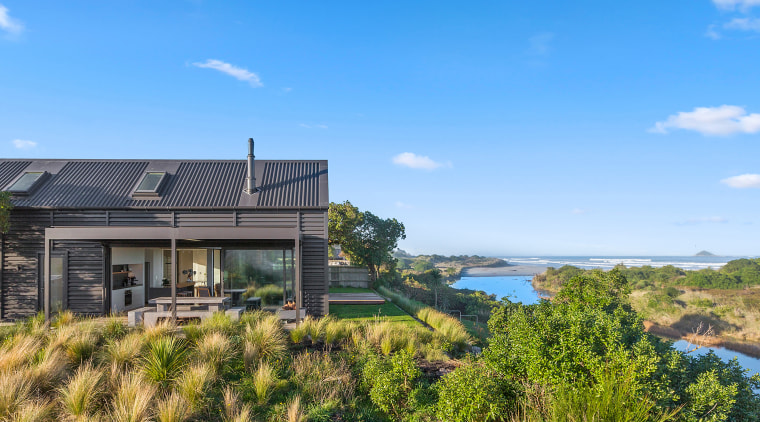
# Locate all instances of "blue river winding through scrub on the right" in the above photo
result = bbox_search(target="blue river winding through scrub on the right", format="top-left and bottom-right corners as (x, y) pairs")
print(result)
(451, 276), (760, 374)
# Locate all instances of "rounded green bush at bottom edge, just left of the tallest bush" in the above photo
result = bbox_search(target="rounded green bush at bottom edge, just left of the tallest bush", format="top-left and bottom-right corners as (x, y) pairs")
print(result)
(436, 364), (515, 422)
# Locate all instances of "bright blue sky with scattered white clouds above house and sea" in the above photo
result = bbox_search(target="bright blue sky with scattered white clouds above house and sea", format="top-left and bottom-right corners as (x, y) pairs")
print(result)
(0, 0), (760, 255)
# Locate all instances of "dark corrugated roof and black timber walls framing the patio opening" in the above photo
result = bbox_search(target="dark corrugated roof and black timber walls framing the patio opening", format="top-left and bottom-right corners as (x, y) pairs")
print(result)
(0, 159), (329, 320)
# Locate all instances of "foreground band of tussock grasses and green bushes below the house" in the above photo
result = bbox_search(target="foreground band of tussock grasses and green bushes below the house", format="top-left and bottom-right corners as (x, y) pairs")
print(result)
(0, 270), (760, 422)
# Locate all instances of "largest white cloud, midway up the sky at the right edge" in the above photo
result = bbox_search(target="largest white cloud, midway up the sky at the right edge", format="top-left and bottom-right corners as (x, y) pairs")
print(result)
(650, 105), (760, 136)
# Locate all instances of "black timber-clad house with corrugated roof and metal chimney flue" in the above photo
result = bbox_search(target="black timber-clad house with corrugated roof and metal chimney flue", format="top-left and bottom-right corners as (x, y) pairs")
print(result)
(0, 140), (329, 320)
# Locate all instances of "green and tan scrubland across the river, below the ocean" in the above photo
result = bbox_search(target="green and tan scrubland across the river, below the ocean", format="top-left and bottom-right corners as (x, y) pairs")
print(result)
(533, 259), (760, 346)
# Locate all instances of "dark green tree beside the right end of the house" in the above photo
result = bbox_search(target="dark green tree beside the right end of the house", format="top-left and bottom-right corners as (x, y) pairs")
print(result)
(327, 201), (406, 281)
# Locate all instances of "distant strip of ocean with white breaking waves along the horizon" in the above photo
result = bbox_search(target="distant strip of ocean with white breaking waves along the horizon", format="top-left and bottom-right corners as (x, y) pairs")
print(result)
(500, 256), (755, 270)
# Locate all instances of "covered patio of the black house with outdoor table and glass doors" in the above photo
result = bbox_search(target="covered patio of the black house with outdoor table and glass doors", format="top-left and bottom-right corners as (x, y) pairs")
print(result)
(42, 227), (306, 325)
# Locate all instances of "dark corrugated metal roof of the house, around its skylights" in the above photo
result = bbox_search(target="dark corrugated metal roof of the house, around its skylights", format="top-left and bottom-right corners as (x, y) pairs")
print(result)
(0, 159), (329, 209)
